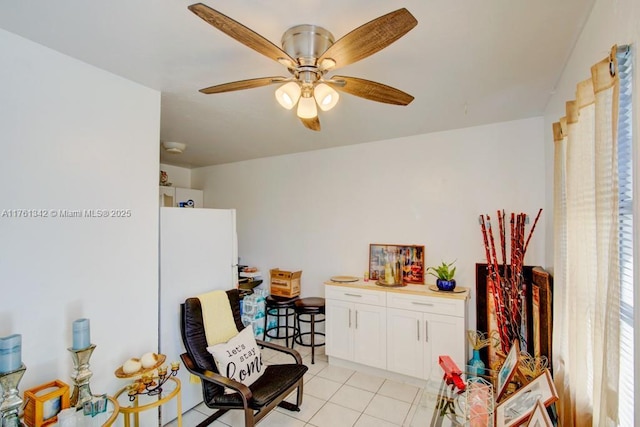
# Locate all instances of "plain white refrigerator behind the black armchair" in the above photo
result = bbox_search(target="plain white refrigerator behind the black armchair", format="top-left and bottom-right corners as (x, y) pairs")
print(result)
(158, 208), (238, 425)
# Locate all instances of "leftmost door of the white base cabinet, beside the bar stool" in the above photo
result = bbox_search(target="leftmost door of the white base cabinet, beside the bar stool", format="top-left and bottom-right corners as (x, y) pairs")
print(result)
(325, 299), (353, 360)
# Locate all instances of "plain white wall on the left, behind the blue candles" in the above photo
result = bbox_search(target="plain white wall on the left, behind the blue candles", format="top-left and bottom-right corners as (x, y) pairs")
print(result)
(0, 26), (160, 408)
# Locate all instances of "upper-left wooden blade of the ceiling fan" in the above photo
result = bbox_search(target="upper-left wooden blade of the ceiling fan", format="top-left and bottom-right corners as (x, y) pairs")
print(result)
(189, 3), (296, 67)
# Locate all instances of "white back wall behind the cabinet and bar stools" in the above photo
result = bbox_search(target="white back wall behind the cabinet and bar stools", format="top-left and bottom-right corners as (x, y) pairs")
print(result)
(192, 118), (546, 326)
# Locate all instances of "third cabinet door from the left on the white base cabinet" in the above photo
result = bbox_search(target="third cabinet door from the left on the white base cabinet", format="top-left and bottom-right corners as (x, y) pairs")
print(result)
(387, 308), (425, 378)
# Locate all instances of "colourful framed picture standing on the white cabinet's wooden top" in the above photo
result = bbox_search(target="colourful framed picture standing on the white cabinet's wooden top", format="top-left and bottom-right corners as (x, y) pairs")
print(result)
(369, 243), (425, 285)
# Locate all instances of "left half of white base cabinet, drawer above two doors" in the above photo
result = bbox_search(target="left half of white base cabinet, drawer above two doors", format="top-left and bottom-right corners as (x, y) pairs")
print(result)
(325, 286), (387, 369)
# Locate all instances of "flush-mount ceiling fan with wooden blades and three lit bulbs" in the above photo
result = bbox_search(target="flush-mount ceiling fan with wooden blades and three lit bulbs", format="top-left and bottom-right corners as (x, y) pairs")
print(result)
(189, 3), (418, 131)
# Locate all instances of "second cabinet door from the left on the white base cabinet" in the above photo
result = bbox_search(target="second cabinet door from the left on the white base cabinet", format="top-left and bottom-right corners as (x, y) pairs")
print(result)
(353, 304), (387, 369)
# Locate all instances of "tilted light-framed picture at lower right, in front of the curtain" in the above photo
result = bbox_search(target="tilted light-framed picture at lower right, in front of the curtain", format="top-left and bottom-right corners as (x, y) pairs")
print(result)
(496, 369), (558, 427)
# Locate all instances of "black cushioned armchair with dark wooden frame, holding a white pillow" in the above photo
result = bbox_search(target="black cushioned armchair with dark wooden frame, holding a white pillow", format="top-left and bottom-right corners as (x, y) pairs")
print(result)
(180, 289), (308, 427)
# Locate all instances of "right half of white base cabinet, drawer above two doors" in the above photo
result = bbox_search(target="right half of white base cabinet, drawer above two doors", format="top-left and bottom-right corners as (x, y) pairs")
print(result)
(387, 293), (467, 379)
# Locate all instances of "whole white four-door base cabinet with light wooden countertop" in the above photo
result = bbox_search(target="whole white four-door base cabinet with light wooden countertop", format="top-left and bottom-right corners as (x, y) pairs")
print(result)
(325, 281), (469, 380)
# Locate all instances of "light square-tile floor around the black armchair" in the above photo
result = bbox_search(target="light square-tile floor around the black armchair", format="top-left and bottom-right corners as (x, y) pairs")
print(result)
(165, 343), (428, 427)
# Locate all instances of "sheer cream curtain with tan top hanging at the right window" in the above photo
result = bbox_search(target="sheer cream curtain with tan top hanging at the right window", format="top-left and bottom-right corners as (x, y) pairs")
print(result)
(553, 47), (620, 426)
